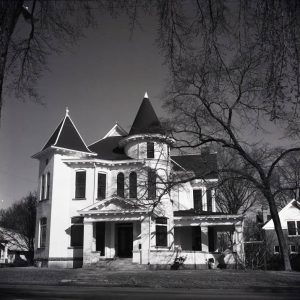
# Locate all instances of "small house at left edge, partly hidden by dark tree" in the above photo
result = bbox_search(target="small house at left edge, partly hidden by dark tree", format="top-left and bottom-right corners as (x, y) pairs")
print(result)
(0, 227), (28, 265)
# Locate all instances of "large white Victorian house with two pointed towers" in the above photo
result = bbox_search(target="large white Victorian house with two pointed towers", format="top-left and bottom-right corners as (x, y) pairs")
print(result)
(33, 94), (243, 268)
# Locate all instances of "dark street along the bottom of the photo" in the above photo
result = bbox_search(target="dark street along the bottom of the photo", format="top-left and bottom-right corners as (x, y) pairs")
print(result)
(0, 284), (300, 300)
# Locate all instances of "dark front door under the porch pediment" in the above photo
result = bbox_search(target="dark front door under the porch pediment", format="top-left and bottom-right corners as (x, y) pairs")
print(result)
(117, 223), (133, 257)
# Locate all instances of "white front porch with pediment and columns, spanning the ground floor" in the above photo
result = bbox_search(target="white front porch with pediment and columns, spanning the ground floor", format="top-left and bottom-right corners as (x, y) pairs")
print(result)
(81, 199), (244, 268)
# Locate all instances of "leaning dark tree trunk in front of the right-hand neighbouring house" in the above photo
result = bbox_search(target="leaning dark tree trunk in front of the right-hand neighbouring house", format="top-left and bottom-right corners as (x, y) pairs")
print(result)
(265, 192), (292, 271)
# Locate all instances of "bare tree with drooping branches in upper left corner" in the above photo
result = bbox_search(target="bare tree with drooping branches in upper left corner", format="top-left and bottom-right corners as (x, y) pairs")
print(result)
(0, 0), (148, 119)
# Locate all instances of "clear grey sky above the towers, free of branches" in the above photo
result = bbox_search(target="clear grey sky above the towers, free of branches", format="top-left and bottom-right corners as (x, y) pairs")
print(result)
(0, 12), (167, 208)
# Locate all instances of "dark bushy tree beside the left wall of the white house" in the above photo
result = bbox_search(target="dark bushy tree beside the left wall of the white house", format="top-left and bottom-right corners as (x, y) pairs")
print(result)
(0, 193), (37, 262)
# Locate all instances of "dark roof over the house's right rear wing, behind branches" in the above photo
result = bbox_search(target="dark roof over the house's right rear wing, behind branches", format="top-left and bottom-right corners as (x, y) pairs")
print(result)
(171, 153), (218, 179)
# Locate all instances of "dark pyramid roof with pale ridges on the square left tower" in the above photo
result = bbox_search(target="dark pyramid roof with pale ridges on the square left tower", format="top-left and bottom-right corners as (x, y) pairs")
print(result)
(42, 109), (91, 153)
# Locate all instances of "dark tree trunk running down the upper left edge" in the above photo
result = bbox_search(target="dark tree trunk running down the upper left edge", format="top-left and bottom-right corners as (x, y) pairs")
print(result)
(0, 0), (23, 120)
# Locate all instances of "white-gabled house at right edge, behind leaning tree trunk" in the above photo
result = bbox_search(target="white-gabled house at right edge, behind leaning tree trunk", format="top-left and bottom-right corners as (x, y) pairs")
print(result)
(262, 200), (300, 254)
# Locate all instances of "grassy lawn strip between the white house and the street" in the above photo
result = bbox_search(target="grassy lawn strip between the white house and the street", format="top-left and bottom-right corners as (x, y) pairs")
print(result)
(0, 267), (300, 289)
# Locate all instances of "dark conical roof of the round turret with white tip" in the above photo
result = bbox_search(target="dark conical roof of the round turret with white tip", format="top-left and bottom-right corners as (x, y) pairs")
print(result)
(129, 93), (164, 135)
